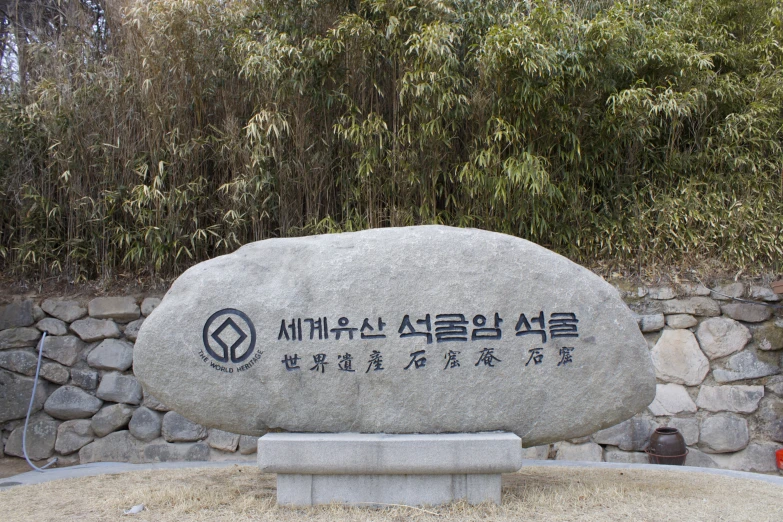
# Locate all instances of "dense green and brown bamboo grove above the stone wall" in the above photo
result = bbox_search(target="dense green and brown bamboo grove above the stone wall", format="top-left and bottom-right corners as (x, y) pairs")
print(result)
(0, 0), (783, 281)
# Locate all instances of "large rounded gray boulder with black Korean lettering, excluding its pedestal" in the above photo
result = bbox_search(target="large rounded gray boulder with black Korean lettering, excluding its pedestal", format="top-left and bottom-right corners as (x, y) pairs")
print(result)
(133, 226), (656, 440)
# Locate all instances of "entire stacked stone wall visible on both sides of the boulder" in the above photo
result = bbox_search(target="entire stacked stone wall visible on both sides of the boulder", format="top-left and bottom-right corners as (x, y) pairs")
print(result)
(0, 281), (783, 472)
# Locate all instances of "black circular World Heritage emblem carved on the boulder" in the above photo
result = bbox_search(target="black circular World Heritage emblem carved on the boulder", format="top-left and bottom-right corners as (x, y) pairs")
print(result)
(203, 308), (256, 363)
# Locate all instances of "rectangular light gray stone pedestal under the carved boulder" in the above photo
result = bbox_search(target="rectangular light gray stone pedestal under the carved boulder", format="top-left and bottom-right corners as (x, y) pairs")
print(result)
(258, 432), (522, 506)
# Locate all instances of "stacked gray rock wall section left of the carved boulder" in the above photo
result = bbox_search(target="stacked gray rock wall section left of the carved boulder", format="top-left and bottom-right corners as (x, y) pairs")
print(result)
(0, 296), (257, 464)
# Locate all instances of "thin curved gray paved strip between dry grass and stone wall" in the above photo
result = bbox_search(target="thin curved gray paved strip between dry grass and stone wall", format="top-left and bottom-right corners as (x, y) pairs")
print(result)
(0, 460), (783, 490)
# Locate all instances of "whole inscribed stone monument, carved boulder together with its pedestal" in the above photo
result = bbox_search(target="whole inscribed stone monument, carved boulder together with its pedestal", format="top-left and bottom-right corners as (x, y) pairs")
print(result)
(134, 226), (655, 505)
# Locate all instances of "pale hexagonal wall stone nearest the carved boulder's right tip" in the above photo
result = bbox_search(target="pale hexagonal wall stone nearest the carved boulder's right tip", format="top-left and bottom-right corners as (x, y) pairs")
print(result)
(650, 330), (710, 386)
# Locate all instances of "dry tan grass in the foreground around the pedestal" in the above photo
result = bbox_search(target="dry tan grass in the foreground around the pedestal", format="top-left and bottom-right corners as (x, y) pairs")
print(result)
(0, 466), (783, 522)
